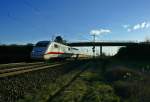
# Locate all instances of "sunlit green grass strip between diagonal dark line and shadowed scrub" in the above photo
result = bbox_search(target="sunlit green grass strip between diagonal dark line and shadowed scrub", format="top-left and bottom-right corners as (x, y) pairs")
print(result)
(52, 61), (120, 102)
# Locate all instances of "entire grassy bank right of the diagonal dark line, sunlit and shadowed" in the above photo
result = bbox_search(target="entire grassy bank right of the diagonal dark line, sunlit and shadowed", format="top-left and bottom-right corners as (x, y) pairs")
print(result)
(49, 59), (150, 102)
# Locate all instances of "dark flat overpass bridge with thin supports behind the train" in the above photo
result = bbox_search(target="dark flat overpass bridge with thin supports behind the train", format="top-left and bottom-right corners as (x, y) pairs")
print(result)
(67, 41), (150, 55)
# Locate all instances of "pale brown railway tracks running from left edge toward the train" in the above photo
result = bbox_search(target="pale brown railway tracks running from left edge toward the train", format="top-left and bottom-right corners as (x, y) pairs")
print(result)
(0, 62), (65, 78)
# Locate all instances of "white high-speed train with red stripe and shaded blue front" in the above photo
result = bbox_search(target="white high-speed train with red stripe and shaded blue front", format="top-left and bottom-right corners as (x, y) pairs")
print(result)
(31, 41), (85, 60)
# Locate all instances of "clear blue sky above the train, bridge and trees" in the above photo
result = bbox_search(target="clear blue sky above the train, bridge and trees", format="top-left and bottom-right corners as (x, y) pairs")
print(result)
(0, 0), (150, 44)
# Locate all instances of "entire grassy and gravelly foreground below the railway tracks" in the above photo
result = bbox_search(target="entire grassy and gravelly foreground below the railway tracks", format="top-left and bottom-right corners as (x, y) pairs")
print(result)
(0, 58), (150, 102)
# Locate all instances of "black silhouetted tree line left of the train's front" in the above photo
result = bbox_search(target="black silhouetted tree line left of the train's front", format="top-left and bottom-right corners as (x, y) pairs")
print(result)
(0, 44), (33, 63)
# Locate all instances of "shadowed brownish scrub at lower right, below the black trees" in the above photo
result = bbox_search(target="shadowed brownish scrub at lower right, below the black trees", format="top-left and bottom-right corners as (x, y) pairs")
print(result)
(105, 59), (150, 102)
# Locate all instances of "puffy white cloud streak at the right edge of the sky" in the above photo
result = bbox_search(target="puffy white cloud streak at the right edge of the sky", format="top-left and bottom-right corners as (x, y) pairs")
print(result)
(123, 22), (150, 32)
